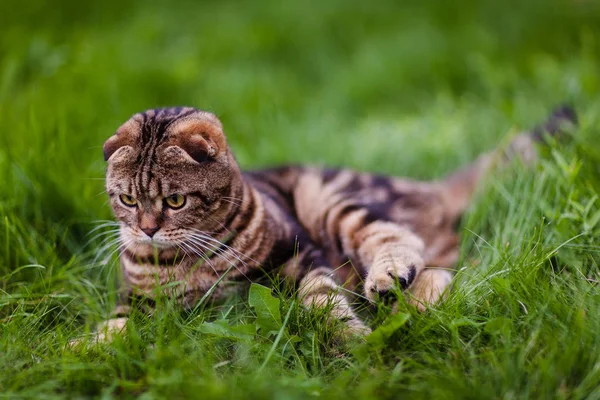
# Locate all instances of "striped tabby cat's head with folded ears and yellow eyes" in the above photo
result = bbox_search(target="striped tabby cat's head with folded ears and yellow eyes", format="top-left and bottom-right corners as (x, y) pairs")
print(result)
(103, 108), (242, 251)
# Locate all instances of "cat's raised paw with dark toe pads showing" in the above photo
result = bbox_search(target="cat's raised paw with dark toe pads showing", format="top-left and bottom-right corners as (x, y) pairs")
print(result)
(365, 251), (424, 301)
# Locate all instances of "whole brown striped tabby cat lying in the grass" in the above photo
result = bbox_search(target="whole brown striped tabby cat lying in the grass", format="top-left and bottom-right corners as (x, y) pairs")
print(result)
(90, 106), (577, 340)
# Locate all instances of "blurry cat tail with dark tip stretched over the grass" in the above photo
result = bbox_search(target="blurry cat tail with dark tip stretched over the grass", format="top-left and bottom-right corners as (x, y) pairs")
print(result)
(442, 105), (578, 217)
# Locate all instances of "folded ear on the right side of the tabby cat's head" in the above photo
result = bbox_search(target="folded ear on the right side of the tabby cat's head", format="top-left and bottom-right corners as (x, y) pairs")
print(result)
(171, 117), (227, 163)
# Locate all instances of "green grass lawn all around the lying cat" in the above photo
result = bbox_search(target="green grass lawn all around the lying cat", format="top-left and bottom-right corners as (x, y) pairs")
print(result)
(0, 0), (600, 399)
